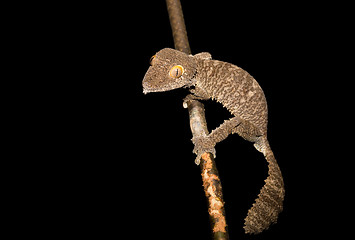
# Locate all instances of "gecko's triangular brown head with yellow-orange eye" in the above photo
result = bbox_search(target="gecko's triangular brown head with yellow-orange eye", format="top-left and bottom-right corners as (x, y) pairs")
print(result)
(142, 48), (196, 94)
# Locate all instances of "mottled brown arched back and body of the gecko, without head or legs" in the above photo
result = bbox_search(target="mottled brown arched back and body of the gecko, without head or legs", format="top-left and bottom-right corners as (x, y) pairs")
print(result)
(197, 60), (267, 135)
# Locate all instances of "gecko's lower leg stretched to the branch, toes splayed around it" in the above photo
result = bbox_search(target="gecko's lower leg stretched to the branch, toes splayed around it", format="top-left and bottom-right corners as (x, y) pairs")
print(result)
(192, 117), (241, 165)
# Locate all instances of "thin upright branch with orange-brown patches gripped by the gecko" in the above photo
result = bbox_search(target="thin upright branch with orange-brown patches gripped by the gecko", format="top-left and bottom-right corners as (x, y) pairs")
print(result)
(166, 0), (229, 240)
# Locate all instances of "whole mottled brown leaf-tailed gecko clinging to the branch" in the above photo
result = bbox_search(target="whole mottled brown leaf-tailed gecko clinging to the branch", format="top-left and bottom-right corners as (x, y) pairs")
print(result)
(142, 48), (285, 234)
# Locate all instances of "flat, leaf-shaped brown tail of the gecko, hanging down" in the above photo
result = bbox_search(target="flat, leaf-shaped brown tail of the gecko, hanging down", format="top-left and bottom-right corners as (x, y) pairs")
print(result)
(244, 138), (285, 234)
